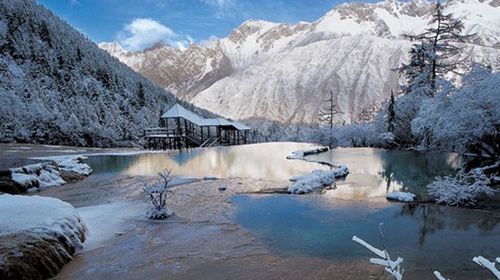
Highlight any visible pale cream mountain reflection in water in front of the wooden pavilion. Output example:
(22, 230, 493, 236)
(123, 143, 325, 181)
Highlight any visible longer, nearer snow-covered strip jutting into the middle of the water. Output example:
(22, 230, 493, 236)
(288, 165, 349, 194)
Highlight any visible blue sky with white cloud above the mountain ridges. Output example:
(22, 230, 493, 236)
(38, 0, 360, 50)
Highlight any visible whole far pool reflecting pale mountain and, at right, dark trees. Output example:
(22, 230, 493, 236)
(89, 143, 460, 200)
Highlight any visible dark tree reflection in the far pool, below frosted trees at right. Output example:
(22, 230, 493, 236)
(379, 151, 459, 195)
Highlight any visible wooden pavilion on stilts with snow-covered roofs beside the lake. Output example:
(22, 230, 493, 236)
(144, 104, 250, 149)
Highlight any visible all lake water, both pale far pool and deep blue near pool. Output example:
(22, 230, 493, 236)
(84, 143, 500, 279)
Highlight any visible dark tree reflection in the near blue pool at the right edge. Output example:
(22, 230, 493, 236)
(400, 203, 500, 245)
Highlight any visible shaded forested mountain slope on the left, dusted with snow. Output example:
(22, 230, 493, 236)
(0, 0, 208, 146)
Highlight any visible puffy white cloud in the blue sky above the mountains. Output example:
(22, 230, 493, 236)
(117, 18, 193, 51)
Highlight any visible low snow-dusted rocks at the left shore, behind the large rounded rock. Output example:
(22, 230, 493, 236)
(9, 156, 92, 190)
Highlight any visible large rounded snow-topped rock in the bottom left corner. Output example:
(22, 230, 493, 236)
(0, 194, 86, 279)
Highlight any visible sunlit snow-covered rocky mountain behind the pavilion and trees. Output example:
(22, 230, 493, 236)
(100, 0, 500, 123)
